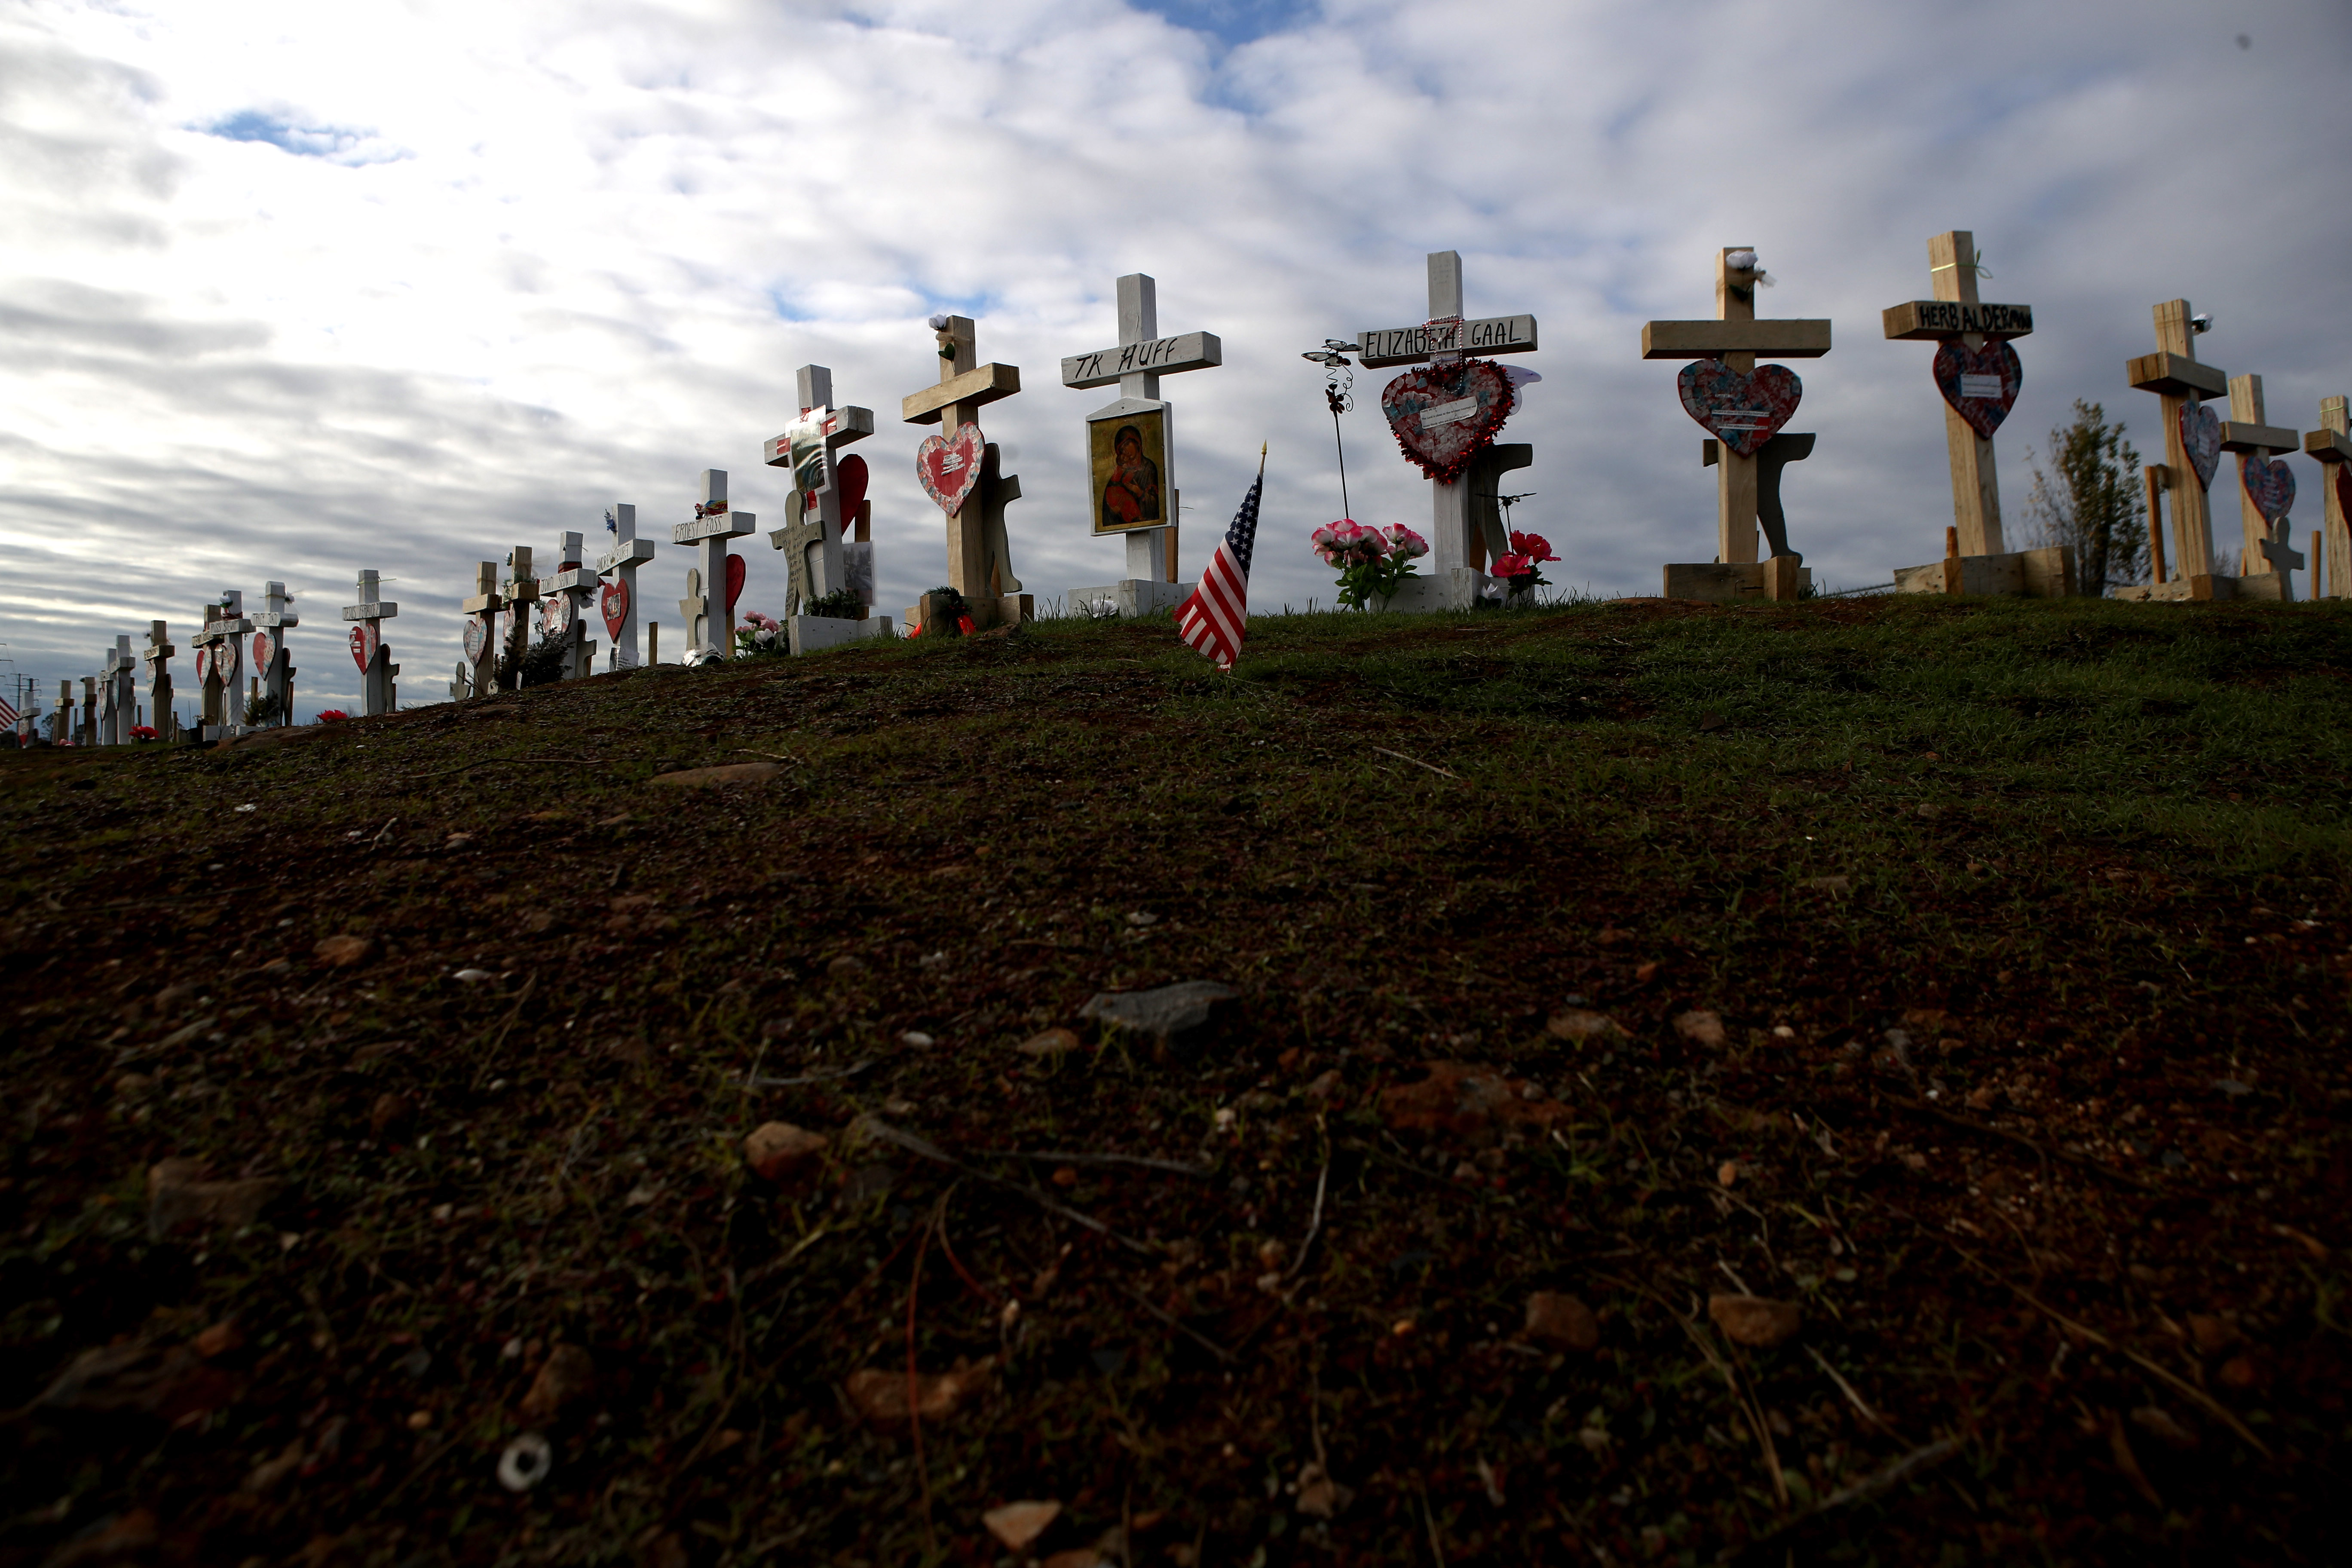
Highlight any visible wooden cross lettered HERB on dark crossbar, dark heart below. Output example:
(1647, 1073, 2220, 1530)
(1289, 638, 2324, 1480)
(1882, 228, 2034, 555)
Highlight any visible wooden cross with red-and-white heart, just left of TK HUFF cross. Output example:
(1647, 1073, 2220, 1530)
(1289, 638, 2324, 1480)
(898, 315, 1032, 630)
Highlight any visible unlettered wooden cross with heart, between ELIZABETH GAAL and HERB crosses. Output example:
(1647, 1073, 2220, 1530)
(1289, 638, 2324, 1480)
(1642, 245, 1830, 576)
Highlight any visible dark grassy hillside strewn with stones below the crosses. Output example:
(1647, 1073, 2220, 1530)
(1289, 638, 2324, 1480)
(0, 600, 2352, 1568)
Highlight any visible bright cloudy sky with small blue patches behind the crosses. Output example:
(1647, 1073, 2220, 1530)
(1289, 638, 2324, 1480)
(0, 0, 2352, 712)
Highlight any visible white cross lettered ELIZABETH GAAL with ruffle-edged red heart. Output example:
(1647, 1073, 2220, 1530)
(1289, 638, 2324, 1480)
(1355, 251, 1536, 574)
